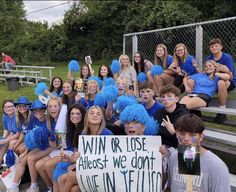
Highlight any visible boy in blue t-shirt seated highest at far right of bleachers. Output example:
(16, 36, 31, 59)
(206, 38, 236, 123)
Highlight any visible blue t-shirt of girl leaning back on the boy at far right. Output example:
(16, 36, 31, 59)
(190, 73, 220, 97)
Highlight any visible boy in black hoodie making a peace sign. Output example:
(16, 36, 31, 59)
(154, 84, 189, 148)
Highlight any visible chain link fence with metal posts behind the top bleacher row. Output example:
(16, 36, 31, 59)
(123, 17, 236, 65)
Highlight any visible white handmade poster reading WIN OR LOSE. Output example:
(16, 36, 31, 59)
(76, 136, 162, 192)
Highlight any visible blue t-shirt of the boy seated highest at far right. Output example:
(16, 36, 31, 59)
(206, 53, 236, 85)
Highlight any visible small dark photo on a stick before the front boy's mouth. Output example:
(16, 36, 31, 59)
(178, 145, 200, 175)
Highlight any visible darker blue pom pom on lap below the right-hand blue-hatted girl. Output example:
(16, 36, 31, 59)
(34, 127, 49, 151)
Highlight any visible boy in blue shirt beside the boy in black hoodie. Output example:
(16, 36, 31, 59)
(139, 81, 164, 117)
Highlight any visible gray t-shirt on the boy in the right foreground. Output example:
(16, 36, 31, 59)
(168, 150, 231, 192)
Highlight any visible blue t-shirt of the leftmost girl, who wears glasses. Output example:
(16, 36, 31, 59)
(2, 114, 20, 134)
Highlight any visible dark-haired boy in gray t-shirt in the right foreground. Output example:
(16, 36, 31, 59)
(160, 114, 231, 192)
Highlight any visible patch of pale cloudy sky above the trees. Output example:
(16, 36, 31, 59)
(23, 0, 72, 26)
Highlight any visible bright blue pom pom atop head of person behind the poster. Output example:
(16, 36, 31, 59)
(120, 104, 149, 125)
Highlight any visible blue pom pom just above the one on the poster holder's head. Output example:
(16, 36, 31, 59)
(115, 95, 137, 112)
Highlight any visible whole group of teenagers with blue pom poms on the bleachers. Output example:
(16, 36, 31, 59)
(0, 39, 236, 192)
